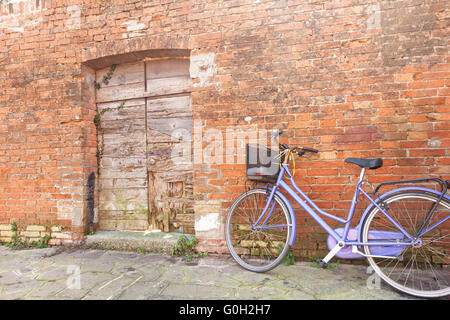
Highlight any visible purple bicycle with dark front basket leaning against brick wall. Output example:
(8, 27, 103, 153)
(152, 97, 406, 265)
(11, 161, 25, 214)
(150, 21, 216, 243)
(225, 131, 450, 298)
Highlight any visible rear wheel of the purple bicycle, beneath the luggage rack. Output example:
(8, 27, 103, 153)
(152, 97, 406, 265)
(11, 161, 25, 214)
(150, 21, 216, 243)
(361, 192, 450, 298)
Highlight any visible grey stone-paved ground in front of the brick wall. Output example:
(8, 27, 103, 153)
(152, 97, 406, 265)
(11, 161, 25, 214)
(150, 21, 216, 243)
(0, 246, 418, 300)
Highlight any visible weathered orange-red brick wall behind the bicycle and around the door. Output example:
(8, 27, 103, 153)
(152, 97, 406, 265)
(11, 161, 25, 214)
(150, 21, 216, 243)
(0, 0, 450, 256)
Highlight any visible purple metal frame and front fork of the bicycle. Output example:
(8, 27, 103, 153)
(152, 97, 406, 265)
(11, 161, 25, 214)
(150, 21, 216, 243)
(253, 164, 448, 251)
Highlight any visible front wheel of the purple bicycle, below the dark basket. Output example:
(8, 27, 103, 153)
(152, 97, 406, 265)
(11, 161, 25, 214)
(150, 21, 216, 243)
(225, 189, 292, 272)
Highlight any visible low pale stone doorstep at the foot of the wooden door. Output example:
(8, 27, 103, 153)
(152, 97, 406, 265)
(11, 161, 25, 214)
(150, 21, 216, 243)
(84, 231, 194, 254)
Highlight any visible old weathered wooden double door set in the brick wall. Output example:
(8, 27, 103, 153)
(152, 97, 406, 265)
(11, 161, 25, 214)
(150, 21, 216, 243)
(96, 58, 194, 233)
